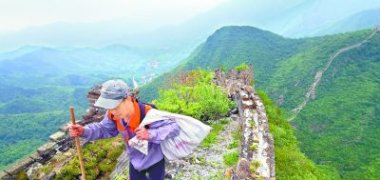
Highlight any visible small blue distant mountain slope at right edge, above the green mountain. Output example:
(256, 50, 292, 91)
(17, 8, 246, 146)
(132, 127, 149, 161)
(317, 9, 380, 35)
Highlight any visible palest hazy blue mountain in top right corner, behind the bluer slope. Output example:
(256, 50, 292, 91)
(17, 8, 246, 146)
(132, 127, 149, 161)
(272, 0, 380, 38)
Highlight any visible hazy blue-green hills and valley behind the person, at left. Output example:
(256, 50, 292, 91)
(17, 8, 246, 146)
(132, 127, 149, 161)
(0, 44, 183, 169)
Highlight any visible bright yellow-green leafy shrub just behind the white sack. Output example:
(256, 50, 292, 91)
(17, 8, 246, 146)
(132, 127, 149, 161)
(153, 70, 234, 121)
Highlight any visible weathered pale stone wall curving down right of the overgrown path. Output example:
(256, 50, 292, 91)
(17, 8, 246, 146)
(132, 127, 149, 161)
(214, 66, 275, 179)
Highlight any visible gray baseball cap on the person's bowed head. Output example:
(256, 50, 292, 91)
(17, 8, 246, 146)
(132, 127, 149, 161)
(94, 79, 130, 109)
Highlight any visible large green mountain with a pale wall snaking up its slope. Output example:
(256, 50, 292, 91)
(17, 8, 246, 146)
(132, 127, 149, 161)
(141, 26, 380, 179)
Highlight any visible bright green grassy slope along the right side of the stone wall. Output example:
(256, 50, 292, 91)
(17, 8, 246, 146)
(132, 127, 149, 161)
(258, 91, 340, 179)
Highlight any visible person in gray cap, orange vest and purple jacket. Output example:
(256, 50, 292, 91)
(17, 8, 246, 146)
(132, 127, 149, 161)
(69, 80, 180, 180)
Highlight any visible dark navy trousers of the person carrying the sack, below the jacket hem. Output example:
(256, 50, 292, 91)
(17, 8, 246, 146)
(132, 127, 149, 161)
(129, 158, 165, 180)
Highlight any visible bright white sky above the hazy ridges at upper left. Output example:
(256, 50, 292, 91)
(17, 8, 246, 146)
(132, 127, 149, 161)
(0, 0, 228, 31)
